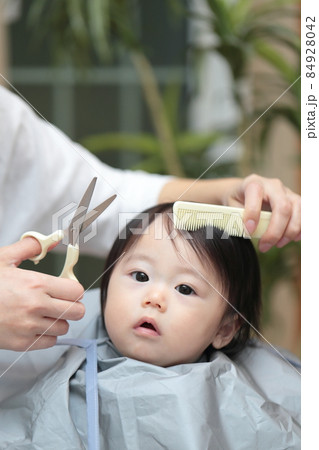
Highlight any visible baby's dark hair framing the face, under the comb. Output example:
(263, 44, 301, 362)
(101, 203, 261, 356)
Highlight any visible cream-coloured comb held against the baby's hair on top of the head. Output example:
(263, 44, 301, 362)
(173, 201, 271, 239)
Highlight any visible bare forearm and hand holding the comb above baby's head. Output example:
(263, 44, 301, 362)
(159, 174, 301, 252)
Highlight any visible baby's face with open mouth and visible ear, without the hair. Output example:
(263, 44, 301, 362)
(104, 221, 234, 367)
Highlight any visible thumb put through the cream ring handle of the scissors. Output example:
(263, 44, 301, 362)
(0, 237, 41, 267)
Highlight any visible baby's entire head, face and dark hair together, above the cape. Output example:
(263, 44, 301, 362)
(101, 204, 261, 367)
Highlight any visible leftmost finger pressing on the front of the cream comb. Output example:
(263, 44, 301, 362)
(243, 181, 264, 234)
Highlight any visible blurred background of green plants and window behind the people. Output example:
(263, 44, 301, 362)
(0, 0, 300, 355)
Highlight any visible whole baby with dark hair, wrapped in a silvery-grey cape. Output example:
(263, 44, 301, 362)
(0, 204, 300, 450)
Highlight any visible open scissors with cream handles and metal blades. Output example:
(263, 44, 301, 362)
(20, 177, 116, 281)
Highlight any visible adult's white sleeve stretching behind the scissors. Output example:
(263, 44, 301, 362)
(0, 87, 169, 257)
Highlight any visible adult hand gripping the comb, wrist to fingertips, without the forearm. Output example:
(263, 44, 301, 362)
(225, 174, 301, 252)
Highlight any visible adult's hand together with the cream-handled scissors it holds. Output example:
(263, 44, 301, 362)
(0, 179, 115, 351)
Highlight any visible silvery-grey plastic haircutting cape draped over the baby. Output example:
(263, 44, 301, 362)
(0, 318, 300, 450)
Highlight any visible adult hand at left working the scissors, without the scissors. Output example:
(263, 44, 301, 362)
(0, 237, 85, 351)
